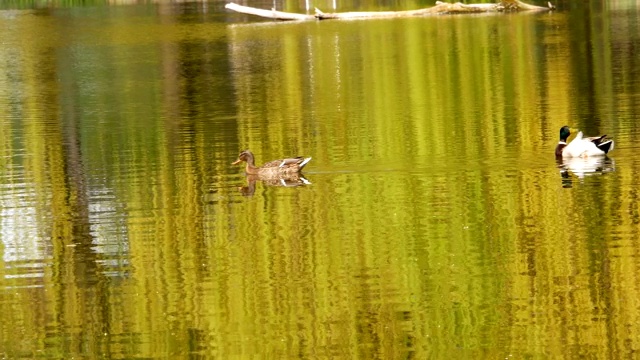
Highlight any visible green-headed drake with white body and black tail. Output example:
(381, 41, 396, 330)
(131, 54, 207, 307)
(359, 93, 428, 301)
(556, 126, 613, 158)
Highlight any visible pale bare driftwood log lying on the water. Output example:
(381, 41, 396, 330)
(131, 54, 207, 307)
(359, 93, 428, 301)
(225, 0, 554, 20)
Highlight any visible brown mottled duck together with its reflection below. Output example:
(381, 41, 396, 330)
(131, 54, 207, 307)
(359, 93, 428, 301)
(233, 150, 311, 196)
